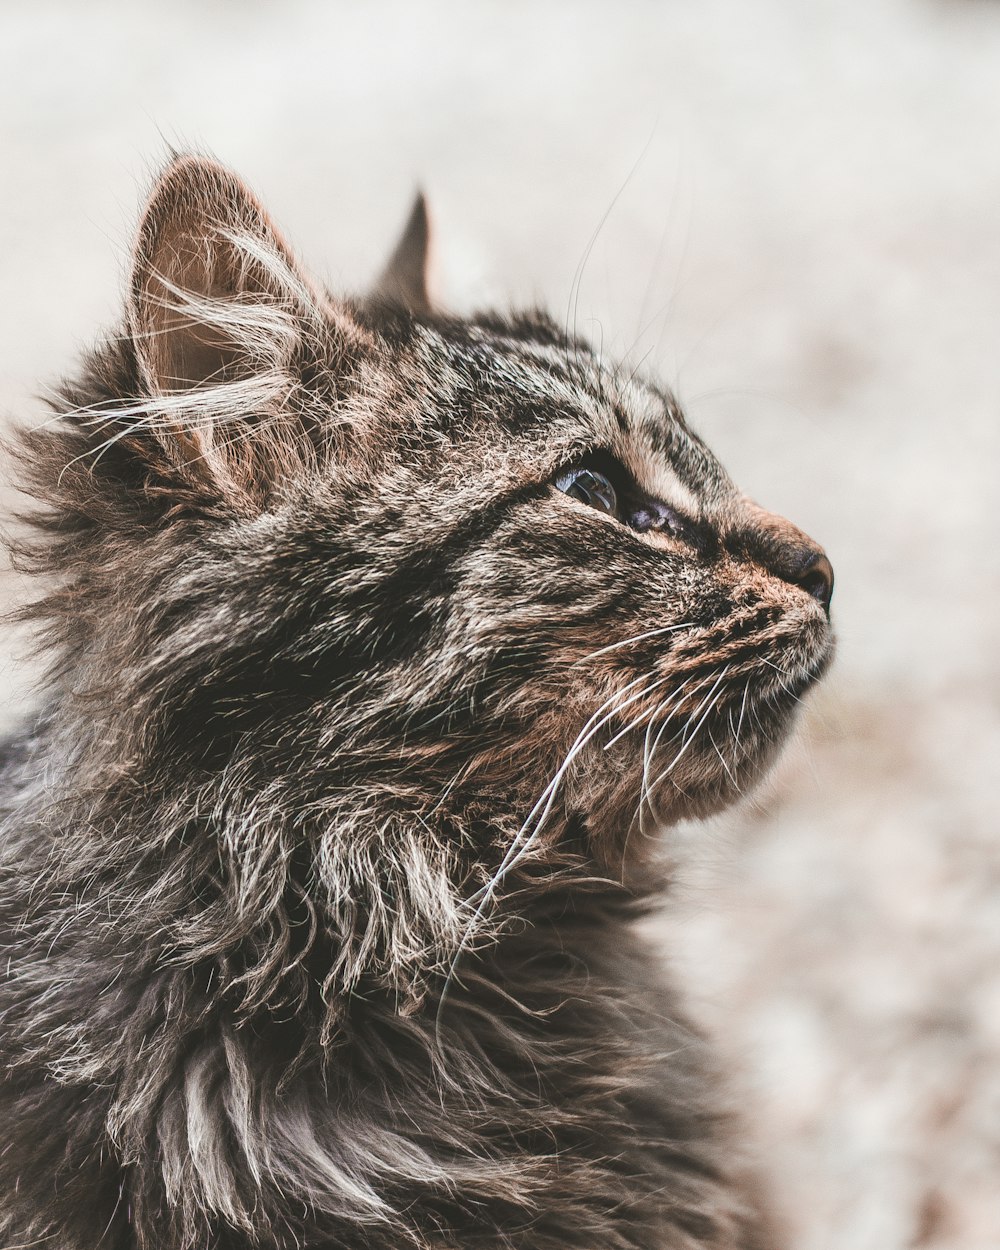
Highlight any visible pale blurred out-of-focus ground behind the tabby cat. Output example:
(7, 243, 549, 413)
(0, 0, 1000, 1250)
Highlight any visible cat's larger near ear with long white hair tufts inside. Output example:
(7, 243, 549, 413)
(123, 156, 339, 503)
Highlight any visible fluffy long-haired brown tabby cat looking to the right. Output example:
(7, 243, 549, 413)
(0, 155, 833, 1250)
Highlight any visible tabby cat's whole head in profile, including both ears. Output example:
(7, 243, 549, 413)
(29, 158, 833, 873)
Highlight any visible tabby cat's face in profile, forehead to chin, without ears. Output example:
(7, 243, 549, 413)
(308, 314, 833, 861)
